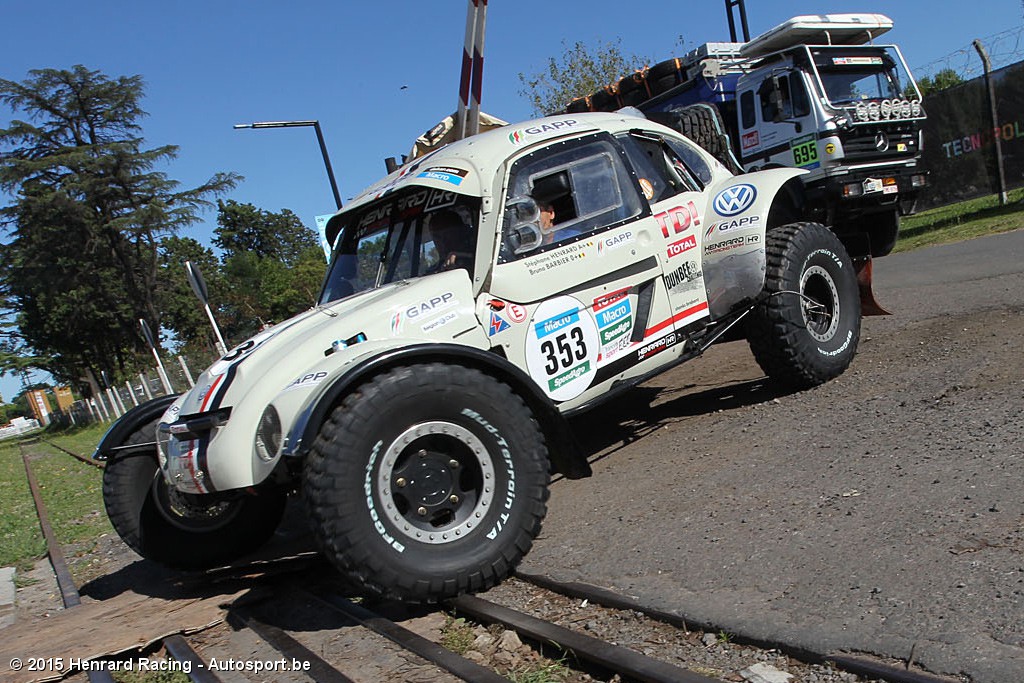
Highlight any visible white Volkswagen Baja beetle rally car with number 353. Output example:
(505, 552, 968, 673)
(97, 114, 860, 601)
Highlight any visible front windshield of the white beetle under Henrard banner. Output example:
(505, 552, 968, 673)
(319, 187, 480, 304)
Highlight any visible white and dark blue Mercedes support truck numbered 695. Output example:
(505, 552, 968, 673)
(566, 14, 928, 313)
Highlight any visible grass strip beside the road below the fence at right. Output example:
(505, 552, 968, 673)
(893, 187, 1024, 252)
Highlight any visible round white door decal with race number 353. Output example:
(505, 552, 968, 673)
(526, 296, 601, 401)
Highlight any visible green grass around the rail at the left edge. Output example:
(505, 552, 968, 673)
(0, 428, 113, 572)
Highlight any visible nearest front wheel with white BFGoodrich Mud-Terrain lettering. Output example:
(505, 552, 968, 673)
(305, 364, 550, 602)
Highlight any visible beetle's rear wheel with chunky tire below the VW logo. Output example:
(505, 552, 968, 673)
(746, 223, 860, 389)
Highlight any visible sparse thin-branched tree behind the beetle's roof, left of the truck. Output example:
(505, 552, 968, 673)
(519, 41, 650, 116)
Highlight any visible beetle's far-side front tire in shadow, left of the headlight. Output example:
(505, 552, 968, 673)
(103, 420, 287, 569)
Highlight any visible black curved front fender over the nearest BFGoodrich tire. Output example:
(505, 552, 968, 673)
(282, 343, 591, 479)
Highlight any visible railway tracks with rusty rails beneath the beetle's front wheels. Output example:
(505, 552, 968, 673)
(8, 444, 952, 683)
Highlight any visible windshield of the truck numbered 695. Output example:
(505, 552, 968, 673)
(812, 46, 921, 105)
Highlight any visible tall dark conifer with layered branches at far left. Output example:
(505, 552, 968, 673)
(0, 65, 239, 389)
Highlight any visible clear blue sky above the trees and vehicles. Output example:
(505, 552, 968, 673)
(0, 0, 1024, 398)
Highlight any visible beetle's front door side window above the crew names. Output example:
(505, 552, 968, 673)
(501, 136, 644, 260)
